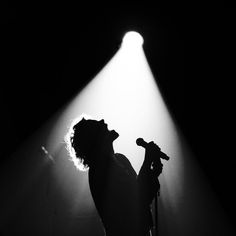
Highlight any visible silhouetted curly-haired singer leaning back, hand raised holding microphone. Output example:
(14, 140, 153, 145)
(65, 118, 162, 236)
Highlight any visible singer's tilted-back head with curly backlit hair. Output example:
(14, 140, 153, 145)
(65, 115, 119, 169)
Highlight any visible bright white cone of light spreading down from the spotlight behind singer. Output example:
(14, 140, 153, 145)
(7, 33, 229, 236)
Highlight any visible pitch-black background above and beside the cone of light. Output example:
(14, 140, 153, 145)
(0, 4, 236, 230)
